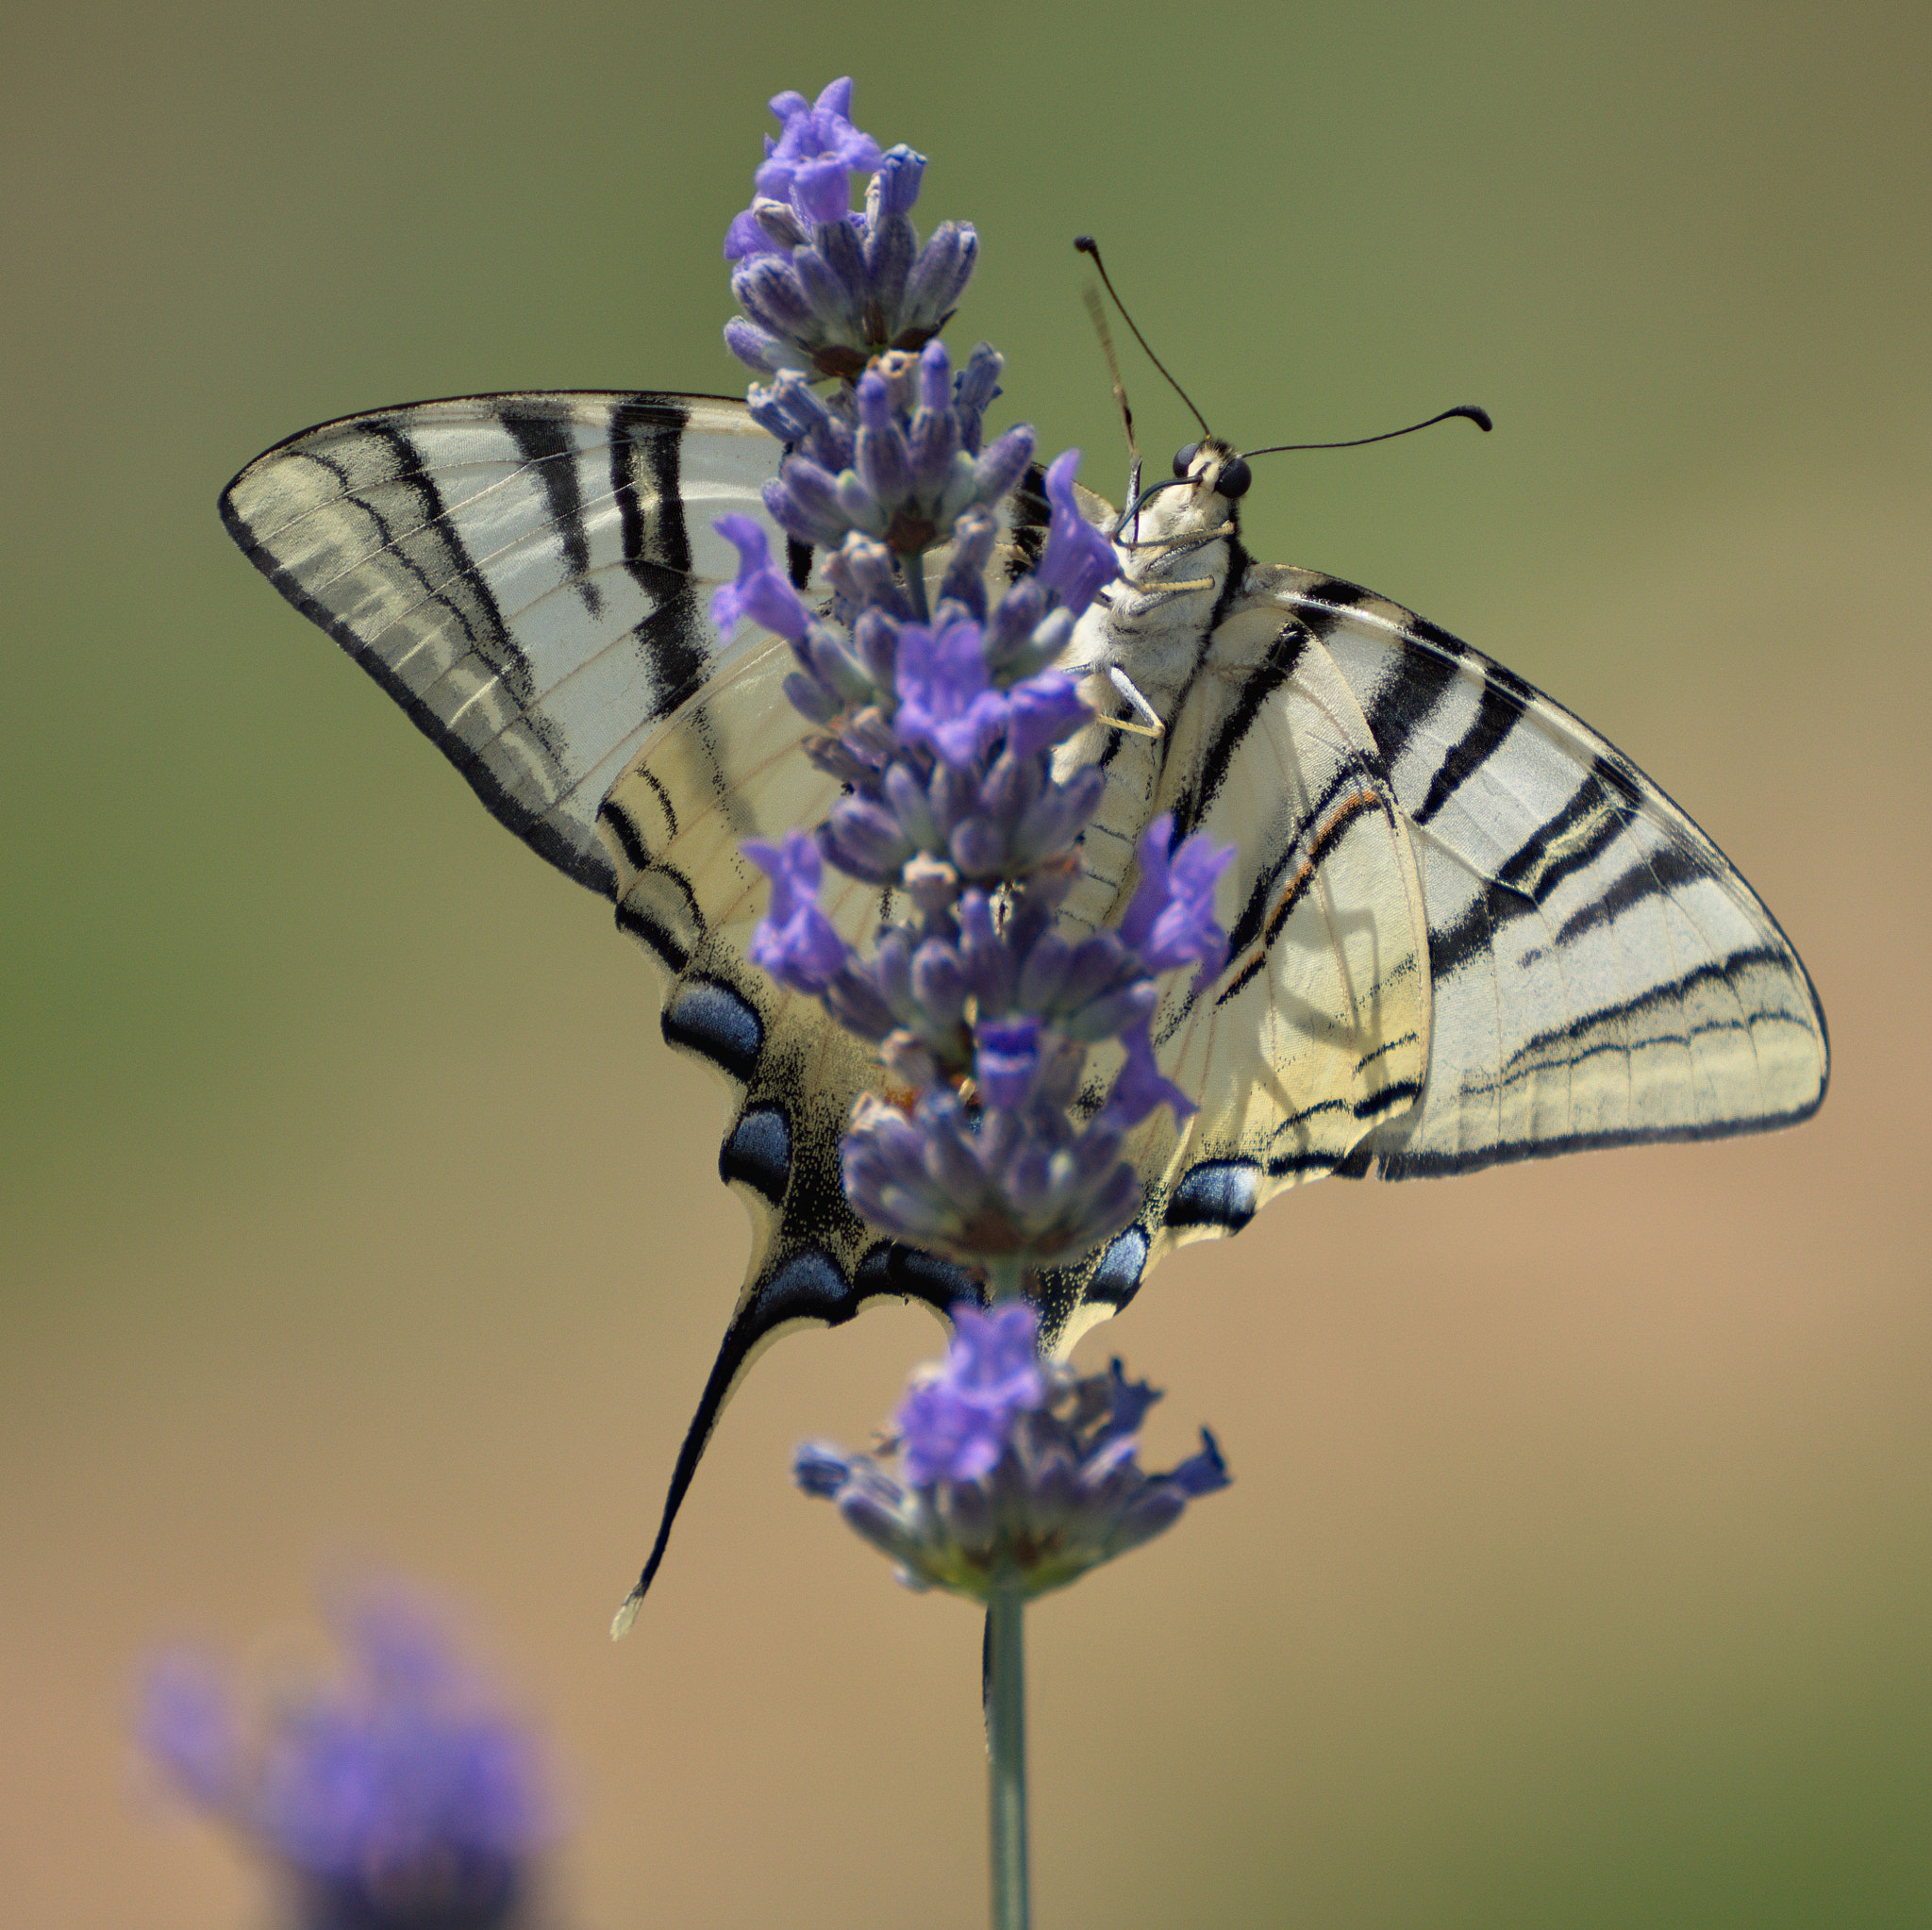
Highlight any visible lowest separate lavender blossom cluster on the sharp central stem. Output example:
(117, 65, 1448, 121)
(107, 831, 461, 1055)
(792, 1302, 1229, 1602)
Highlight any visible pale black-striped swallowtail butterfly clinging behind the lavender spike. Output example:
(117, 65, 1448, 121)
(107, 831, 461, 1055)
(220, 380, 1827, 1622)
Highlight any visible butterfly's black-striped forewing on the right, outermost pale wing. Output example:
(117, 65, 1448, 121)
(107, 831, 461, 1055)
(1244, 568, 1827, 1178)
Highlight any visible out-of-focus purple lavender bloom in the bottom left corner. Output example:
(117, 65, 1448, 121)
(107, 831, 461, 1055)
(142, 1594, 553, 1930)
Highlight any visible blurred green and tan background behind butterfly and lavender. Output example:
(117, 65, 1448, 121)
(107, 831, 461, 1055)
(0, 0, 1932, 1930)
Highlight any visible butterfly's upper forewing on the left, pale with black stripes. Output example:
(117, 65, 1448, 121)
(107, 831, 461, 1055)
(223, 394, 809, 892)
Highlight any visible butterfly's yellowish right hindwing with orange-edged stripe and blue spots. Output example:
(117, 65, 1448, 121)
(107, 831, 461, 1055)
(1060, 607, 1430, 1333)
